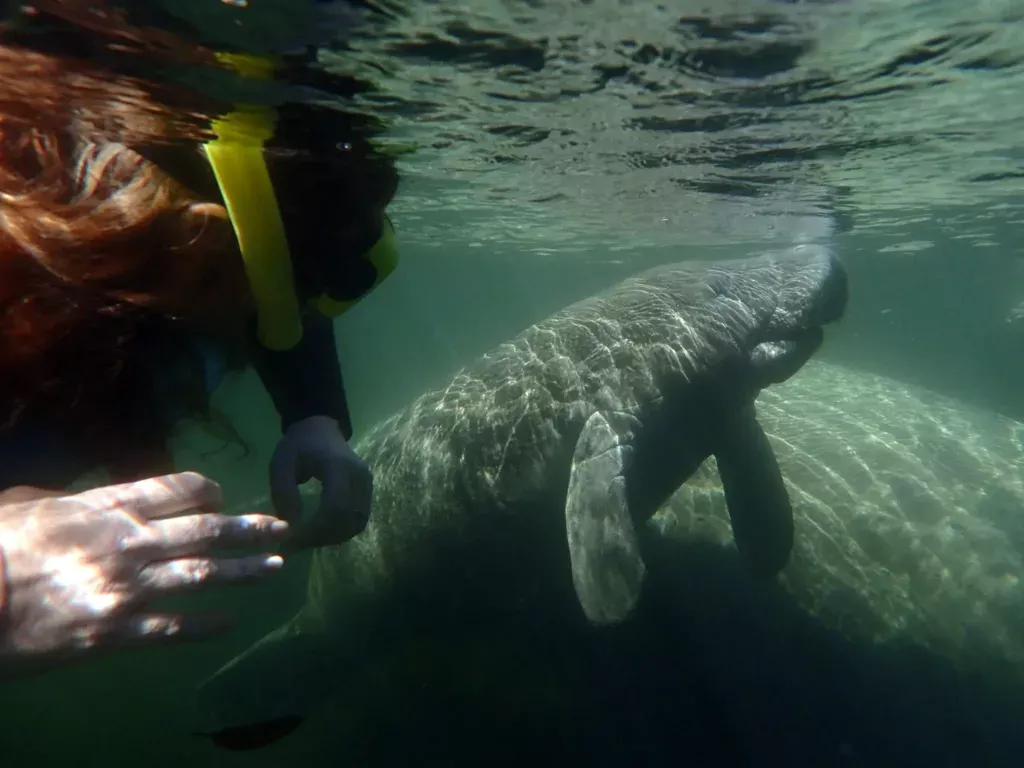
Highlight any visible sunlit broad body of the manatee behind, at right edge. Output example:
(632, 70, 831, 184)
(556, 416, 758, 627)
(650, 361, 1024, 680)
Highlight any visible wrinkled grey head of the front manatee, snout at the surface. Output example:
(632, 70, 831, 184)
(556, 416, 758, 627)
(618, 245, 848, 409)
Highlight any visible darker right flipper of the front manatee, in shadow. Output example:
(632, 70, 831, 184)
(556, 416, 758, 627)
(715, 404, 794, 577)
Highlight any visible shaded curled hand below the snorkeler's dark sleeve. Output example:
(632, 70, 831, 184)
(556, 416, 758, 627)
(270, 416, 374, 552)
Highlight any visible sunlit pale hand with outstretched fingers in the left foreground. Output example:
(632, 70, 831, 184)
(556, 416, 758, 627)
(0, 472, 288, 676)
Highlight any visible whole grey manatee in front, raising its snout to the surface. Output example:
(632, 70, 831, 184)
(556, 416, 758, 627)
(200, 244, 847, 748)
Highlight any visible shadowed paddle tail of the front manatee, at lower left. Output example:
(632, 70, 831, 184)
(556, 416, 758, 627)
(199, 612, 333, 750)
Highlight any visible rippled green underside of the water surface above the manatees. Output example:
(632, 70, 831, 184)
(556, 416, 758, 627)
(280, 0, 1024, 253)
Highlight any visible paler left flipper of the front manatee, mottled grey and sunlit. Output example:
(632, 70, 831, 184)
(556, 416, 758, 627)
(565, 412, 645, 625)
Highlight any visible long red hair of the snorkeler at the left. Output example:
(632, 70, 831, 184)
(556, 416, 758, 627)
(0, 31, 249, 487)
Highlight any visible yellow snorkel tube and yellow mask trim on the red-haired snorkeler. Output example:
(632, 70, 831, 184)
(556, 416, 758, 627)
(198, 53, 398, 350)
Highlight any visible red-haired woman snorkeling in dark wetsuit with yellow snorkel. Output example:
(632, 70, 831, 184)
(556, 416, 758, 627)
(0, 2, 397, 671)
